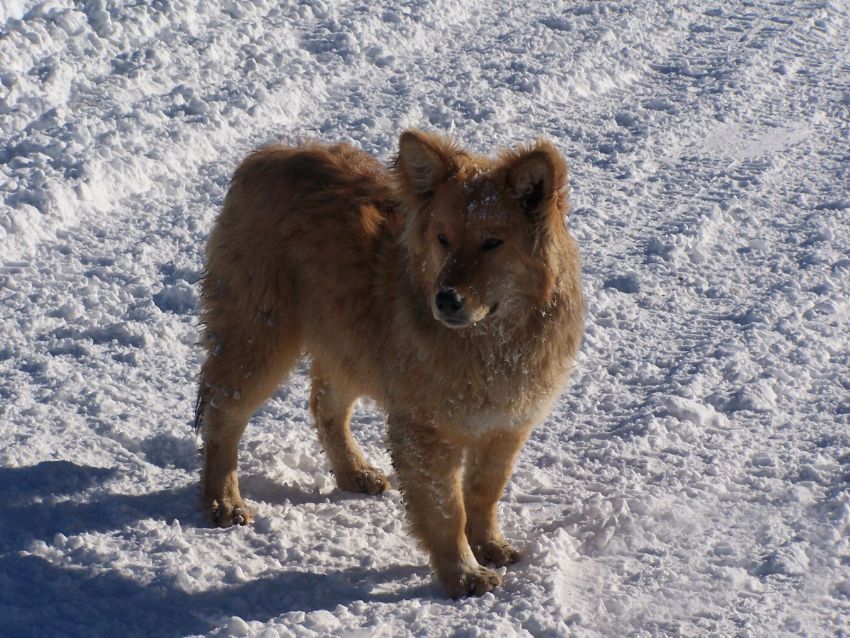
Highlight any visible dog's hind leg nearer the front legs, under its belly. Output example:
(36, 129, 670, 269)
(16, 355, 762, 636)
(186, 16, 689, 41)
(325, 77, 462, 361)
(310, 362, 390, 494)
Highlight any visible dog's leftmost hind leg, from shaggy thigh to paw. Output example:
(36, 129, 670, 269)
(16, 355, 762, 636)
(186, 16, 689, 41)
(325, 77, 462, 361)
(198, 322, 300, 527)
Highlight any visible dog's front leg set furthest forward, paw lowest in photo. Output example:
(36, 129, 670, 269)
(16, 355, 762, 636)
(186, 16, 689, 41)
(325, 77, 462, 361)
(389, 416, 502, 598)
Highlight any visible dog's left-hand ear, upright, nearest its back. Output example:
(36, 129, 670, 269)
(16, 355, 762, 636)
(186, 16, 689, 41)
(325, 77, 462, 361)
(396, 130, 457, 198)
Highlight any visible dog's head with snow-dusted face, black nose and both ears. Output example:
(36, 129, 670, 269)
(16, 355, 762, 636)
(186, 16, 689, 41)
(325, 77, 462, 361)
(395, 131, 569, 328)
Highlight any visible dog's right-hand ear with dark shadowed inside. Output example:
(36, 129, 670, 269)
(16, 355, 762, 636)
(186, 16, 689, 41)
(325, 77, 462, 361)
(505, 140, 567, 221)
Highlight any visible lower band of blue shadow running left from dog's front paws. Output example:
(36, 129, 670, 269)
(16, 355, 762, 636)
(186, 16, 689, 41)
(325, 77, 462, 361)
(0, 553, 430, 638)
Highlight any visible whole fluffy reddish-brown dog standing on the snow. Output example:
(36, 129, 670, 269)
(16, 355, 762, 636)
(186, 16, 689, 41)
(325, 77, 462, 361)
(196, 131, 584, 596)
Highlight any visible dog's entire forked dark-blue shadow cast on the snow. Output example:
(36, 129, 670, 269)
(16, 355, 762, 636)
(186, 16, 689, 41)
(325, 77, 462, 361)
(0, 461, 440, 638)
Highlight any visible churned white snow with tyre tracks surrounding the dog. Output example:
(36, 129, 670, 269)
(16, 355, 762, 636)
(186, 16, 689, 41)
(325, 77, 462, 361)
(0, 0, 850, 637)
